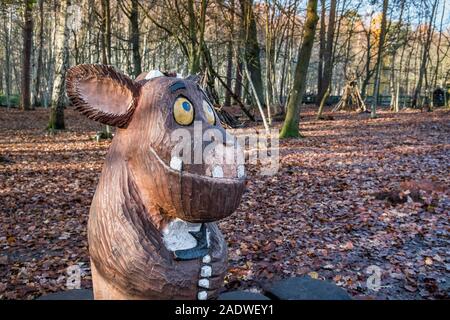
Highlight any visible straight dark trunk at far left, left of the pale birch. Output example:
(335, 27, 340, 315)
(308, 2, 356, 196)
(20, 0, 34, 110)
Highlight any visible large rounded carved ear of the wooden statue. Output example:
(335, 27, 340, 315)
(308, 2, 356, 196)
(66, 64, 140, 128)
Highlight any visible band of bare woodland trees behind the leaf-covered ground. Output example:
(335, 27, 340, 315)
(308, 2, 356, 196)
(0, 0, 450, 128)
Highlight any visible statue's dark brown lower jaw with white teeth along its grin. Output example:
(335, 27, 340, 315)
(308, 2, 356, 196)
(143, 148, 245, 223)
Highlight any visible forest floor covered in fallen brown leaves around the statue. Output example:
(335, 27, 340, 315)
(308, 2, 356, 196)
(0, 108, 450, 299)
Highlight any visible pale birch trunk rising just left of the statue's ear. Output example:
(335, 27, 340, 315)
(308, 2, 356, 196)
(48, 0, 70, 130)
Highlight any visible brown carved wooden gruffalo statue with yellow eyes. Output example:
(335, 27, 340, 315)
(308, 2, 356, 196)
(66, 65, 245, 300)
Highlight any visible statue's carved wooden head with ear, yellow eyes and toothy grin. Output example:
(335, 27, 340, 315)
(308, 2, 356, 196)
(66, 65, 245, 225)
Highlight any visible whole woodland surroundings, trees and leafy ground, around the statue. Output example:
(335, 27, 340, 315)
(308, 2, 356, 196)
(0, 0, 450, 299)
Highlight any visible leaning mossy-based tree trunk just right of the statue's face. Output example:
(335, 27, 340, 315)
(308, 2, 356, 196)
(280, 0, 319, 138)
